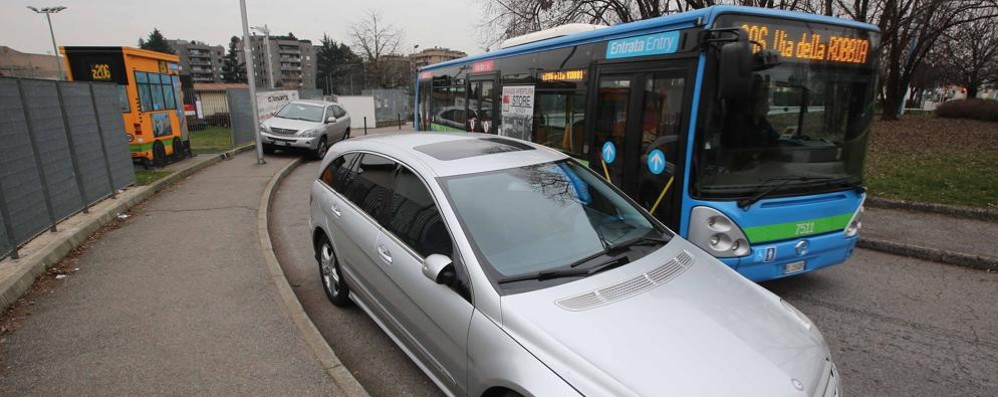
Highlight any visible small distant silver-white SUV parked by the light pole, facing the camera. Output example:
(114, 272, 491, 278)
(260, 100, 350, 159)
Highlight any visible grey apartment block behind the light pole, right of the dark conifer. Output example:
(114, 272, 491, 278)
(239, 35, 317, 88)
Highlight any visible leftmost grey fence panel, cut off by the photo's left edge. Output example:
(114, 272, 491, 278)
(0, 79, 53, 246)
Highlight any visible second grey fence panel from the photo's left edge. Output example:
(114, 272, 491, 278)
(21, 80, 83, 219)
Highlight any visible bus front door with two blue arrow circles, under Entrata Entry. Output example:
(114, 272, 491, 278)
(589, 64, 691, 230)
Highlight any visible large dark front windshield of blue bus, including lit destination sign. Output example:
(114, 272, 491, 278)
(694, 16, 877, 198)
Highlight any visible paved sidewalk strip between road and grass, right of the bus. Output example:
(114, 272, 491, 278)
(860, 206, 998, 267)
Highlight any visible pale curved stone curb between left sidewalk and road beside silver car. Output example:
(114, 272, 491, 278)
(256, 158, 369, 397)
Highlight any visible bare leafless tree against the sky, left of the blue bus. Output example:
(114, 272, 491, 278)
(350, 9, 403, 87)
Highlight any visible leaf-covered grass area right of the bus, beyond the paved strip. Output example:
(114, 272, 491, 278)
(866, 117, 998, 208)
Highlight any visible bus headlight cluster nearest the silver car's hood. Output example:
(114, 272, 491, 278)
(689, 207, 751, 258)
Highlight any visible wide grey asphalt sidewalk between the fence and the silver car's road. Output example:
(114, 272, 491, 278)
(0, 152, 341, 395)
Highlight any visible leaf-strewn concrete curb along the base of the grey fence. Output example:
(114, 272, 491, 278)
(0, 146, 253, 311)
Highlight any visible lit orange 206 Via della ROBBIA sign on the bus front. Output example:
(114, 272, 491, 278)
(734, 22, 870, 65)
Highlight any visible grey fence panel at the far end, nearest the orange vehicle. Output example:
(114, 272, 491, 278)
(94, 84, 135, 189)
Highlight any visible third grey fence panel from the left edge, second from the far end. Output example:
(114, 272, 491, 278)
(61, 83, 111, 203)
